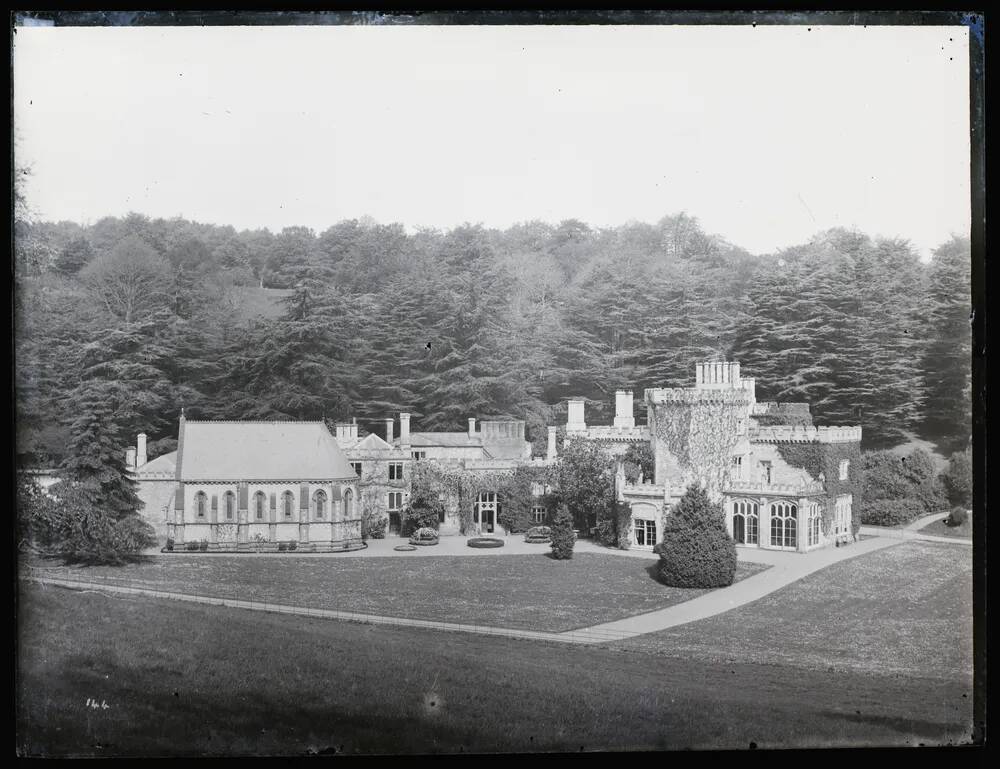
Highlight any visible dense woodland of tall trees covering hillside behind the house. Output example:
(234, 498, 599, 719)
(14, 207, 971, 465)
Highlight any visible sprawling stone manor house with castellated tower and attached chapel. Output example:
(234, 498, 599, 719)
(127, 362, 861, 552)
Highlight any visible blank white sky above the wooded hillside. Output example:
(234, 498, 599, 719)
(14, 26, 970, 255)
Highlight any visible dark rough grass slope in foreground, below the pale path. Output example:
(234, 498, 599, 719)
(15, 584, 972, 756)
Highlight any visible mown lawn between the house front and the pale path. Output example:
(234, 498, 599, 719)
(21, 553, 766, 632)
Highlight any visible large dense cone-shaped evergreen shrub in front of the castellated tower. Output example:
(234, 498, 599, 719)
(653, 484, 736, 588)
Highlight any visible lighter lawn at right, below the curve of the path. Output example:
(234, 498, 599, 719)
(615, 541, 972, 681)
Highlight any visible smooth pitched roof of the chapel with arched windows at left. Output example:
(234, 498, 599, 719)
(177, 421, 357, 481)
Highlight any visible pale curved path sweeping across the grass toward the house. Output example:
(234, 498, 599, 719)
(26, 537, 916, 644)
